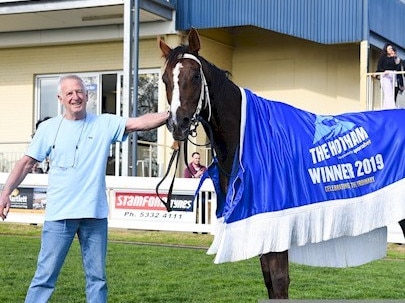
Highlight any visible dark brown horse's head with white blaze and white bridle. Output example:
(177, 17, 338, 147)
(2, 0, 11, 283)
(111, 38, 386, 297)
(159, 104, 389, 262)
(159, 29, 210, 141)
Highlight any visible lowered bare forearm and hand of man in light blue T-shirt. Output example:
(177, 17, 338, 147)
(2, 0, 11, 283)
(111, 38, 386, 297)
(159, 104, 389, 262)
(0, 156, 37, 221)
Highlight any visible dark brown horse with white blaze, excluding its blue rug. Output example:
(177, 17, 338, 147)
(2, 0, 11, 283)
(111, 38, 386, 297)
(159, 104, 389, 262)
(158, 28, 405, 299)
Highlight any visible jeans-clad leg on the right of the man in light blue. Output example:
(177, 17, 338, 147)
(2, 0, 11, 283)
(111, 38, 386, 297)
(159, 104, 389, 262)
(78, 219, 108, 303)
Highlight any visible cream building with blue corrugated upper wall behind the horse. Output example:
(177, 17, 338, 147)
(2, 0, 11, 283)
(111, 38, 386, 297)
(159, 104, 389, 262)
(0, 0, 405, 176)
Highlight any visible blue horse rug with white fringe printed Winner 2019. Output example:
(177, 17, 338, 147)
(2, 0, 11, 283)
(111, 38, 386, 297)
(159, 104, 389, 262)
(201, 89, 405, 267)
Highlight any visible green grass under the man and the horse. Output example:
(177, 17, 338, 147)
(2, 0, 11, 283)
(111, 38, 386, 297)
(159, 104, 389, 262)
(0, 223, 405, 303)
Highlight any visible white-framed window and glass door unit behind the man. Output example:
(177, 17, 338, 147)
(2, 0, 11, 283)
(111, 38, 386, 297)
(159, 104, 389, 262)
(34, 69, 159, 176)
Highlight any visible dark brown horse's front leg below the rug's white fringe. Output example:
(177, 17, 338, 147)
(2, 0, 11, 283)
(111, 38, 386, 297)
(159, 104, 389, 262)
(260, 251, 290, 299)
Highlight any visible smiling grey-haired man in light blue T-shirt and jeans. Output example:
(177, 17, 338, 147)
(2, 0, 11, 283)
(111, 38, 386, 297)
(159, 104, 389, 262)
(0, 75, 168, 303)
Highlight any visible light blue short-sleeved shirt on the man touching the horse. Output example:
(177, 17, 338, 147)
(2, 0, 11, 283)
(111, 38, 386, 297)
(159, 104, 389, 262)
(26, 113, 127, 221)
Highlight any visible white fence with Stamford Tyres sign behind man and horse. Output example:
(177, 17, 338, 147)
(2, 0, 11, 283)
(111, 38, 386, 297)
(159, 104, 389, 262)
(0, 173, 216, 234)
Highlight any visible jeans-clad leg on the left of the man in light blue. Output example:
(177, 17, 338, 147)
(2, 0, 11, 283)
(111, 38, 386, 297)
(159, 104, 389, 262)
(25, 220, 78, 303)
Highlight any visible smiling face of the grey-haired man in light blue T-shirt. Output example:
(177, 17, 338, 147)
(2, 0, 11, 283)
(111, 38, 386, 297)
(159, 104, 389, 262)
(58, 79, 87, 115)
